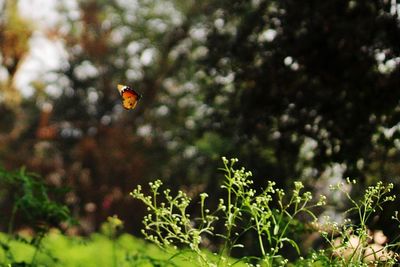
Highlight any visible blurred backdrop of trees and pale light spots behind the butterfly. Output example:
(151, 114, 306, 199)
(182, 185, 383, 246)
(0, 0, 400, 244)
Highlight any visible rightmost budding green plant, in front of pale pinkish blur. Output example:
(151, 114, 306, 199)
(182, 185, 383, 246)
(319, 179, 399, 266)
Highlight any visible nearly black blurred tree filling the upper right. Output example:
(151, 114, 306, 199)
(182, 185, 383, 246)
(198, 0, 400, 188)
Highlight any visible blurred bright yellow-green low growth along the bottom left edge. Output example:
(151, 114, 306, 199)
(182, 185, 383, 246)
(0, 231, 250, 267)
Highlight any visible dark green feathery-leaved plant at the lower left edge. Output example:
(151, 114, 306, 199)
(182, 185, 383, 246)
(0, 168, 73, 266)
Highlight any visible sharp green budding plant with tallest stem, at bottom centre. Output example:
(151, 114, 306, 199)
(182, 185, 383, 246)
(131, 158, 325, 266)
